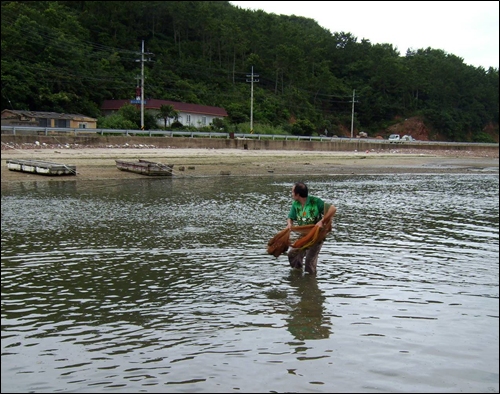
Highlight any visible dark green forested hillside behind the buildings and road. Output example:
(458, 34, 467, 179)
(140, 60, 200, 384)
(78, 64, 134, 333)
(1, 1, 499, 142)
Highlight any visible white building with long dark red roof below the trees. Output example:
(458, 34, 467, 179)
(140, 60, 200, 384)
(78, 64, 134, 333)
(101, 99, 228, 127)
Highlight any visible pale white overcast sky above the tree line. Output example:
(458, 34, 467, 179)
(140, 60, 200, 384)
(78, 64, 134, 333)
(230, 1, 499, 70)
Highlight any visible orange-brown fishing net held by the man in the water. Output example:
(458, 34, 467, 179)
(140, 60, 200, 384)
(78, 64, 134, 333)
(267, 203, 336, 258)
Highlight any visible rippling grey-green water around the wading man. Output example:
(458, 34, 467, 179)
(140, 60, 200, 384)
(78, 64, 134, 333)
(1, 174, 499, 393)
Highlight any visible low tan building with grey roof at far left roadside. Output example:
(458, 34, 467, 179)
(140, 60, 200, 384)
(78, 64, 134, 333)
(2, 109, 97, 129)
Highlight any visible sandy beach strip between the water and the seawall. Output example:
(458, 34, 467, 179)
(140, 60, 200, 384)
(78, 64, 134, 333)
(1, 145, 498, 183)
